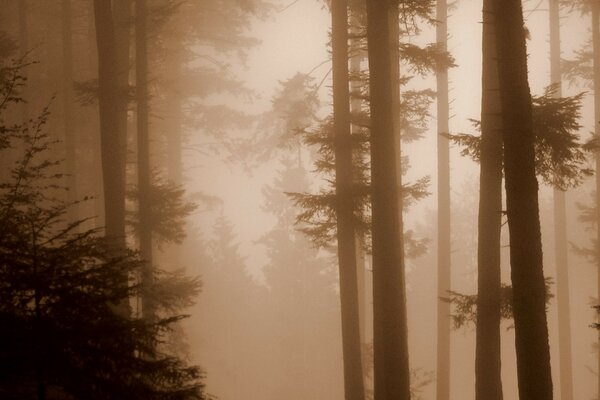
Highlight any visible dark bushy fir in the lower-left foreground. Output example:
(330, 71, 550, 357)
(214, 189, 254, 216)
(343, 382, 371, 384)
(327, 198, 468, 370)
(0, 67, 204, 400)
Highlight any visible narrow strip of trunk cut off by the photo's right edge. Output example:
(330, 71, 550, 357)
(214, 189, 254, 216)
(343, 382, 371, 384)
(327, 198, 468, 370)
(592, 1, 600, 396)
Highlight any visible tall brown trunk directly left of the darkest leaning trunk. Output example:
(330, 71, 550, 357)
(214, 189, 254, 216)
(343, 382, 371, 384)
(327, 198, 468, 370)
(475, 0, 502, 400)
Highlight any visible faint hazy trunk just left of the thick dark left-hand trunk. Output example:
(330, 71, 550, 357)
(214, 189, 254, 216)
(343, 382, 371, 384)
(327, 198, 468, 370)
(62, 0, 79, 221)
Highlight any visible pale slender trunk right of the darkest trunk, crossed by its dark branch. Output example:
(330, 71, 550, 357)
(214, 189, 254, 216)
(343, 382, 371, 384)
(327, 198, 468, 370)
(549, 0, 573, 400)
